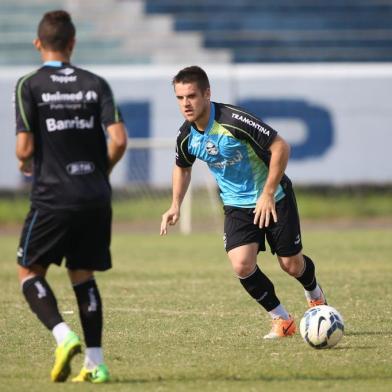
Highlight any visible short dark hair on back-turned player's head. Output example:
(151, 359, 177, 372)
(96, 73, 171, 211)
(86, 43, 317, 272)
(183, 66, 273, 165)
(37, 10, 76, 52)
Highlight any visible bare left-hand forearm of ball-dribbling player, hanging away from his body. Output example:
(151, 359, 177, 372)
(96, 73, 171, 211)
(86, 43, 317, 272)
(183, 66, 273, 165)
(160, 165, 192, 235)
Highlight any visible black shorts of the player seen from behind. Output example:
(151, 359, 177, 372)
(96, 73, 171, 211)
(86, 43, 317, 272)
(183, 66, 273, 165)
(17, 206, 112, 271)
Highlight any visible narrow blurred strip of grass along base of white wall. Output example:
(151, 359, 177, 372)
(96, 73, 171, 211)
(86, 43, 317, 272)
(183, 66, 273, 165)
(0, 188, 392, 228)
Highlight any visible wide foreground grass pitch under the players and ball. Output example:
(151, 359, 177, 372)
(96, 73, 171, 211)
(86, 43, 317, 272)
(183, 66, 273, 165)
(0, 229, 392, 392)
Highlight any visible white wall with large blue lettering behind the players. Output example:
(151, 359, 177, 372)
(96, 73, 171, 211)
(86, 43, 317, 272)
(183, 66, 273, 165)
(0, 64, 392, 188)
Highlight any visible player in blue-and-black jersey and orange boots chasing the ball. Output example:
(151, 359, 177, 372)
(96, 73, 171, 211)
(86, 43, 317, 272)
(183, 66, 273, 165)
(160, 66, 326, 339)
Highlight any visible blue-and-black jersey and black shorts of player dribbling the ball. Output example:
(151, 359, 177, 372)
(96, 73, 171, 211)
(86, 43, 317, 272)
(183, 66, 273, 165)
(176, 102, 302, 256)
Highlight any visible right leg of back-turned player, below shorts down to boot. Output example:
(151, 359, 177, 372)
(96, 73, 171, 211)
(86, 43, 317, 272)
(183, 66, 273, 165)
(68, 270, 109, 383)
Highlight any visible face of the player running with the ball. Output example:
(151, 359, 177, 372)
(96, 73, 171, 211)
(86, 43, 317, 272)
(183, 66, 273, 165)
(174, 82, 211, 123)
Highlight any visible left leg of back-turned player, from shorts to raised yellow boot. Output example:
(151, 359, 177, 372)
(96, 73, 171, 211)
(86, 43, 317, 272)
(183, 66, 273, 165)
(18, 210, 81, 381)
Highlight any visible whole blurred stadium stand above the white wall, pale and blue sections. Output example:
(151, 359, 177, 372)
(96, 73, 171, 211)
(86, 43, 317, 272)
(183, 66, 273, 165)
(0, 0, 392, 65)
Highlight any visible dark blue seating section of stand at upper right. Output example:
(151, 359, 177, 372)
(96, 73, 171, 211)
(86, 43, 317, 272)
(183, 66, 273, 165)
(146, 0, 392, 63)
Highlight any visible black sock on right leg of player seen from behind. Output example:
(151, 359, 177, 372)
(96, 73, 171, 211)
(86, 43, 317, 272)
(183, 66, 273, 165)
(74, 279, 102, 347)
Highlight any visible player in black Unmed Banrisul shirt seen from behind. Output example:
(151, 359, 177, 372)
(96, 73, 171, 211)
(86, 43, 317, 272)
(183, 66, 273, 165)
(15, 11, 127, 383)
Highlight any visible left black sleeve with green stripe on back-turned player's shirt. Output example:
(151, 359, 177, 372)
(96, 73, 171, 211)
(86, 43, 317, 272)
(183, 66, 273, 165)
(14, 75, 35, 133)
